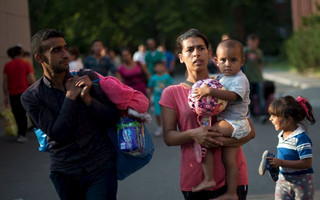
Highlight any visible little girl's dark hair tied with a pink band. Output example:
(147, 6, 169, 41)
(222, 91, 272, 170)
(268, 96, 316, 124)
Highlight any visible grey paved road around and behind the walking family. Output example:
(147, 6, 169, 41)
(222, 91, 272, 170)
(0, 70, 320, 200)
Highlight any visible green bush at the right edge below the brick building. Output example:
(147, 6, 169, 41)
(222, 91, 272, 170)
(285, 16, 320, 72)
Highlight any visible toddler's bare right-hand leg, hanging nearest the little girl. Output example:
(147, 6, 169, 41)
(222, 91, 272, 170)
(215, 147, 239, 200)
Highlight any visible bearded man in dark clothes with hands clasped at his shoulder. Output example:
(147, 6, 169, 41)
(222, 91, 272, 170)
(21, 29, 119, 200)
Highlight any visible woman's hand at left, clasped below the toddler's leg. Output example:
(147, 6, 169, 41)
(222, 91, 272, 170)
(192, 126, 223, 148)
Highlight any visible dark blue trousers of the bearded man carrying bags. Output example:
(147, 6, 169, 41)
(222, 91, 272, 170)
(50, 162, 118, 200)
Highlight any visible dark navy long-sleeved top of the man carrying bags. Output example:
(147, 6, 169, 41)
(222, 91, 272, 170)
(21, 70, 119, 175)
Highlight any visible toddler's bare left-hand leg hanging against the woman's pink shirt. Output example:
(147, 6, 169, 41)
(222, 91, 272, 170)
(192, 149, 216, 192)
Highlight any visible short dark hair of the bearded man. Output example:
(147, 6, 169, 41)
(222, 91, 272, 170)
(31, 29, 64, 55)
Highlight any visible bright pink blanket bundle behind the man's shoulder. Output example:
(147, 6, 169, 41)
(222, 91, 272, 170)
(98, 74, 149, 113)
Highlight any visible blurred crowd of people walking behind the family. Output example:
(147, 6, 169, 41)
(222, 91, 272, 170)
(3, 31, 269, 142)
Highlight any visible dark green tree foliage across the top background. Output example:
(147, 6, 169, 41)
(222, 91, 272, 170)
(29, 0, 287, 53)
